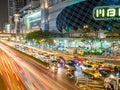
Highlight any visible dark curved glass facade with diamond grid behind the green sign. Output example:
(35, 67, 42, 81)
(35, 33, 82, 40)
(56, 0, 120, 31)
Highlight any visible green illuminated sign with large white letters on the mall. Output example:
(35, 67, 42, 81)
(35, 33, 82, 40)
(93, 6, 120, 20)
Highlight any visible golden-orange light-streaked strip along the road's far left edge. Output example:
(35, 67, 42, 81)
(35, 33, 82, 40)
(0, 46, 26, 90)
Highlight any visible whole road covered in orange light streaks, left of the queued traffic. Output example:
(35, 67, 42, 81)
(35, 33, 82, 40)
(0, 44, 79, 90)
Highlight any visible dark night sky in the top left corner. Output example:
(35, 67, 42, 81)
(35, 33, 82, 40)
(0, 0, 8, 29)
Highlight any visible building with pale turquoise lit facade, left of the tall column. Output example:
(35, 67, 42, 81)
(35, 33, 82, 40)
(19, 0, 41, 33)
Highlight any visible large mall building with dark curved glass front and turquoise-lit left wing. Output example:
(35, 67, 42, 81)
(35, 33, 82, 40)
(20, 0, 120, 32)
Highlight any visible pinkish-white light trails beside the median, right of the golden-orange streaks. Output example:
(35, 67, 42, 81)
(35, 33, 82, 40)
(0, 44, 78, 90)
